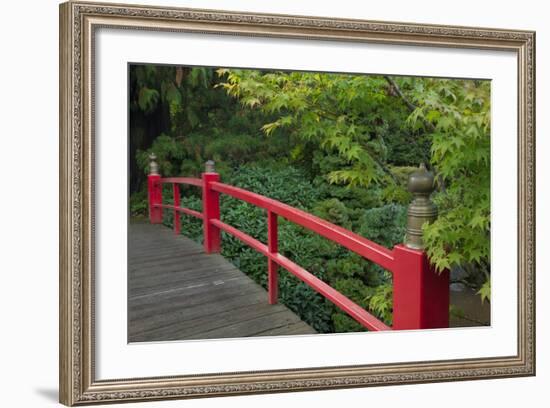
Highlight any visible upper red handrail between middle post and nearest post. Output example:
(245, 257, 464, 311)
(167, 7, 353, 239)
(212, 182, 394, 270)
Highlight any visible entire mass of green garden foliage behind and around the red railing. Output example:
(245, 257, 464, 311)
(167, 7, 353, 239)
(130, 65, 490, 332)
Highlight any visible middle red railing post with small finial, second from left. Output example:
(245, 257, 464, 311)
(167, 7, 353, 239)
(202, 160, 221, 254)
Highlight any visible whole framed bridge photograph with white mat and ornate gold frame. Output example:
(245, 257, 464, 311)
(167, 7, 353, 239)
(60, 2, 535, 405)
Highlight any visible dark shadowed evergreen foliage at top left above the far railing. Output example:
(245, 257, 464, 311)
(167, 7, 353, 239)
(130, 65, 280, 192)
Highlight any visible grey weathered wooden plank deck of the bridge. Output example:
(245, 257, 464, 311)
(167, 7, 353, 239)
(128, 223, 315, 342)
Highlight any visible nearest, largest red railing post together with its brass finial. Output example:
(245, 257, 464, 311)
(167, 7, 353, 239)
(393, 165, 449, 330)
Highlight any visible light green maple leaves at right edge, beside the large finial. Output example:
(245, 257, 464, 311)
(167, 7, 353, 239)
(402, 79, 490, 286)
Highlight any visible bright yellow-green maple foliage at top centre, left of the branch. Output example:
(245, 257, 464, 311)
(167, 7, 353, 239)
(218, 69, 412, 186)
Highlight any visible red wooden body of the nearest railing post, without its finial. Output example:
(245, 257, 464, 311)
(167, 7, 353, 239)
(393, 245, 449, 330)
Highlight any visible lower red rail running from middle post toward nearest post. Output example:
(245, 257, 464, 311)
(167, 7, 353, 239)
(212, 220, 391, 331)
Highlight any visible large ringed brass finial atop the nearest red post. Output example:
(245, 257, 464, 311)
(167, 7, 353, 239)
(405, 163, 437, 249)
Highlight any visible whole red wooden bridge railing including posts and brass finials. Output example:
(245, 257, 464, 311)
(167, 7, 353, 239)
(148, 156, 449, 331)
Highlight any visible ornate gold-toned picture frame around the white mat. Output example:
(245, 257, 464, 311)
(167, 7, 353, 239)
(59, 2, 535, 405)
